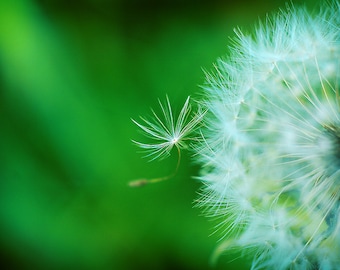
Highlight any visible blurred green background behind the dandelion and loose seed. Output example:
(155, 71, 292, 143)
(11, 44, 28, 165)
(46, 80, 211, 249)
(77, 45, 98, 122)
(0, 0, 313, 269)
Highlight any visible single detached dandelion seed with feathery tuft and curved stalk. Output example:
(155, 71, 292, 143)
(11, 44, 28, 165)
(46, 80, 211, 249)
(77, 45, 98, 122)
(130, 96, 205, 187)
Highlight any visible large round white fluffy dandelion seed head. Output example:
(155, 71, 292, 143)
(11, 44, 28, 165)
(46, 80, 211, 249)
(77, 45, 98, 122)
(195, 2, 340, 269)
